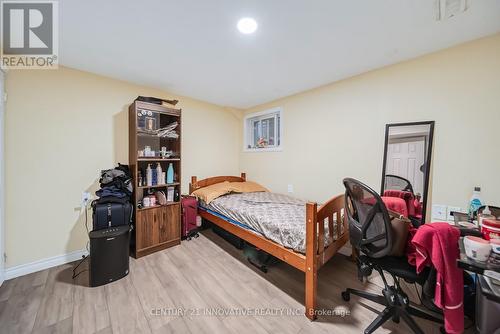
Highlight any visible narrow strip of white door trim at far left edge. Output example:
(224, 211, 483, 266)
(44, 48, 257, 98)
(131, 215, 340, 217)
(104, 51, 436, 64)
(0, 70, 5, 285)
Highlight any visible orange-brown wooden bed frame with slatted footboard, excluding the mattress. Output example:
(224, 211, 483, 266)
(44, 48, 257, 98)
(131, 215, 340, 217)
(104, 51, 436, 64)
(189, 173, 349, 320)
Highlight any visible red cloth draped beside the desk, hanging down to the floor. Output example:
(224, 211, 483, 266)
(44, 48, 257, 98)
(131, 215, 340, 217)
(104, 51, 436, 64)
(408, 223, 464, 333)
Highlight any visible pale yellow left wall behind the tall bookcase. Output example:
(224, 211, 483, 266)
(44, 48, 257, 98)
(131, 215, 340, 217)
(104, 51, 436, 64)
(5, 68, 240, 267)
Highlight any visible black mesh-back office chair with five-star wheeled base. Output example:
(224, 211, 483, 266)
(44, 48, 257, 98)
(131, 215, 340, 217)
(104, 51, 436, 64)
(342, 178, 443, 334)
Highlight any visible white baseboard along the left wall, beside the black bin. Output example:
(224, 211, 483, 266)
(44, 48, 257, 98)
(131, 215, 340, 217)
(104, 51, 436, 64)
(4, 249, 88, 280)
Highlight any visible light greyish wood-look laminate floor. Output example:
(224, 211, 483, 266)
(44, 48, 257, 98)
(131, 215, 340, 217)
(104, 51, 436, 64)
(0, 231, 458, 334)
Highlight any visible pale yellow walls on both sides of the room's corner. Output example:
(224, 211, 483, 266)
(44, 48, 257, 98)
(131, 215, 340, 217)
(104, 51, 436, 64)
(5, 35, 500, 267)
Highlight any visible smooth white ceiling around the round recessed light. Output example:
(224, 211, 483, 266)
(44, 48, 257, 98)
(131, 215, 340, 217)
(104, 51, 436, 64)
(60, 0, 500, 108)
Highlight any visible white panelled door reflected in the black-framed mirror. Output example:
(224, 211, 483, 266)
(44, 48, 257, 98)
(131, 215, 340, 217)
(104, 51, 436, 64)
(386, 138, 425, 194)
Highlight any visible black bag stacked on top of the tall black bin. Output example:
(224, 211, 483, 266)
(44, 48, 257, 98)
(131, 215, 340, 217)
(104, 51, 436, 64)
(92, 202, 132, 231)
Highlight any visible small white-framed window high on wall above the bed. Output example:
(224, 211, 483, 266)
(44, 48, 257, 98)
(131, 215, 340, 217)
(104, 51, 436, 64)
(243, 108, 283, 151)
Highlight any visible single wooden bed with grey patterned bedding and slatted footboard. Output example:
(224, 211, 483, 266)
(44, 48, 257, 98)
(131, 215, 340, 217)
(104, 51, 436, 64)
(189, 173, 349, 320)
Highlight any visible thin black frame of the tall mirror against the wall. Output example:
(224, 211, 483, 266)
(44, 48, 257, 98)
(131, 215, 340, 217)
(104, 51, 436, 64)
(380, 121, 436, 225)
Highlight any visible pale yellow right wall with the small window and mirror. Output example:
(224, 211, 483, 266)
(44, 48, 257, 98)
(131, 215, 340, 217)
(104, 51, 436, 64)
(240, 34, 500, 211)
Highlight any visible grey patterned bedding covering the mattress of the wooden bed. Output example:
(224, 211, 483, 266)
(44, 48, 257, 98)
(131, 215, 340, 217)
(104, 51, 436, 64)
(203, 192, 332, 253)
